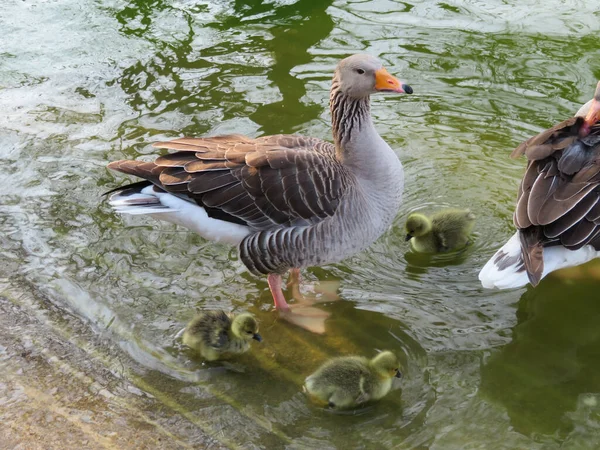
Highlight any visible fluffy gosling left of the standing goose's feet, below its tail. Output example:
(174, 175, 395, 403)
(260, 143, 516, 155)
(182, 311, 262, 361)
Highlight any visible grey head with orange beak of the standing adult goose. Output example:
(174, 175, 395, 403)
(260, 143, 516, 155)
(334, 54, 413, 98)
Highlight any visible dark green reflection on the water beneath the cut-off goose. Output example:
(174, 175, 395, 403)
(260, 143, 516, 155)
(481, 270, 600, 439)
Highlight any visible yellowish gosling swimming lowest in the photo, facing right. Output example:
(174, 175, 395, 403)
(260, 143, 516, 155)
(304, 351, 402, 409)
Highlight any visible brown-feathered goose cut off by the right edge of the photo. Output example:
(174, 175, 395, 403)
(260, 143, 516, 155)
(479, 82, 600, 289)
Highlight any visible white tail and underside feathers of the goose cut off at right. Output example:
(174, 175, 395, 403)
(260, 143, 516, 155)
(479, 231, 600, 289)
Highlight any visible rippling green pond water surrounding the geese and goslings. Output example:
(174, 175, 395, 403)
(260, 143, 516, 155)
(0, 0, 600, 449)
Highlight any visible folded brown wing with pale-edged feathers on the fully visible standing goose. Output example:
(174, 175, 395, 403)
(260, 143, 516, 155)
(108, 135, 351, 230)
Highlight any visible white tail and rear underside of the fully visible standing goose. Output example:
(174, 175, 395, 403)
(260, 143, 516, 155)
(109, 186, 250, 245)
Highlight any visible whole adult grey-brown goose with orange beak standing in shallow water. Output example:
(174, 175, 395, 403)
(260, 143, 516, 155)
(108, 55, 412, 332)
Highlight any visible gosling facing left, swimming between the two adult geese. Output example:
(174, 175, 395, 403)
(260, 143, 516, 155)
(406, 209, 475, 253)
